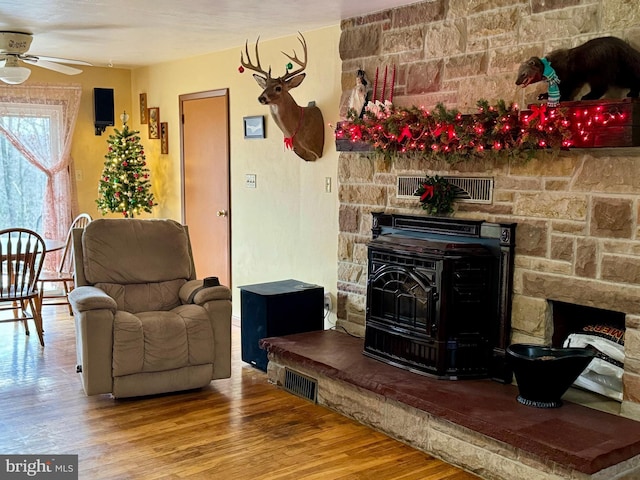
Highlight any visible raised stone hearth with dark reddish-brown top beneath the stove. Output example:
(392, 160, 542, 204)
(261, 330, 640, 480)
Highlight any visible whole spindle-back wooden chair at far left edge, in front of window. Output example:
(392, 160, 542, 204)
(0, 228, 46, 347)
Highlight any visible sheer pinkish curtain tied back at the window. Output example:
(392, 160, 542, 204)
(0, 84, 82, 244)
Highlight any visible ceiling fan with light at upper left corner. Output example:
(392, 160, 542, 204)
(0, 32, 91, 85)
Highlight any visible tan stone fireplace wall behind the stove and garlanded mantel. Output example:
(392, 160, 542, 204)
(338, 0, 640, 418)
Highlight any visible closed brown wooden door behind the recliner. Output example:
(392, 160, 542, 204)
(179, 89, 231, 287)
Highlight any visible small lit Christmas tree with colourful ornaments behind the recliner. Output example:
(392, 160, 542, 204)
(96, 113, 157, 218)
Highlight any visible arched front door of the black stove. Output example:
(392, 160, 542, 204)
(367, 265, 438, 338)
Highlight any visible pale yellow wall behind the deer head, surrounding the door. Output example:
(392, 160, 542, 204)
(130, 26, 341, 319)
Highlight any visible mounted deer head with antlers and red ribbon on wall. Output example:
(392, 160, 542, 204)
(240, 33, 324, 161)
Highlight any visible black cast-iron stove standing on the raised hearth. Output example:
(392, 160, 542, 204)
(364, 213, 515, 382)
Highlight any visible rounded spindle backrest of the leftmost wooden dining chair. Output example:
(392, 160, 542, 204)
(0, 228, 46, 300)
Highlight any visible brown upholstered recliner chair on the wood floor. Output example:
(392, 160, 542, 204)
(69, 219, 231, 398)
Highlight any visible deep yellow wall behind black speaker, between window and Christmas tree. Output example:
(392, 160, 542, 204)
(25, 67, 133, 218)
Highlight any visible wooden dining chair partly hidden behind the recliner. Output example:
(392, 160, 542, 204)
(38, 213, 92, 315)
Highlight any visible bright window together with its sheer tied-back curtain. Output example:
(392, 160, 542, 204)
(0, 84, 82, 244)
